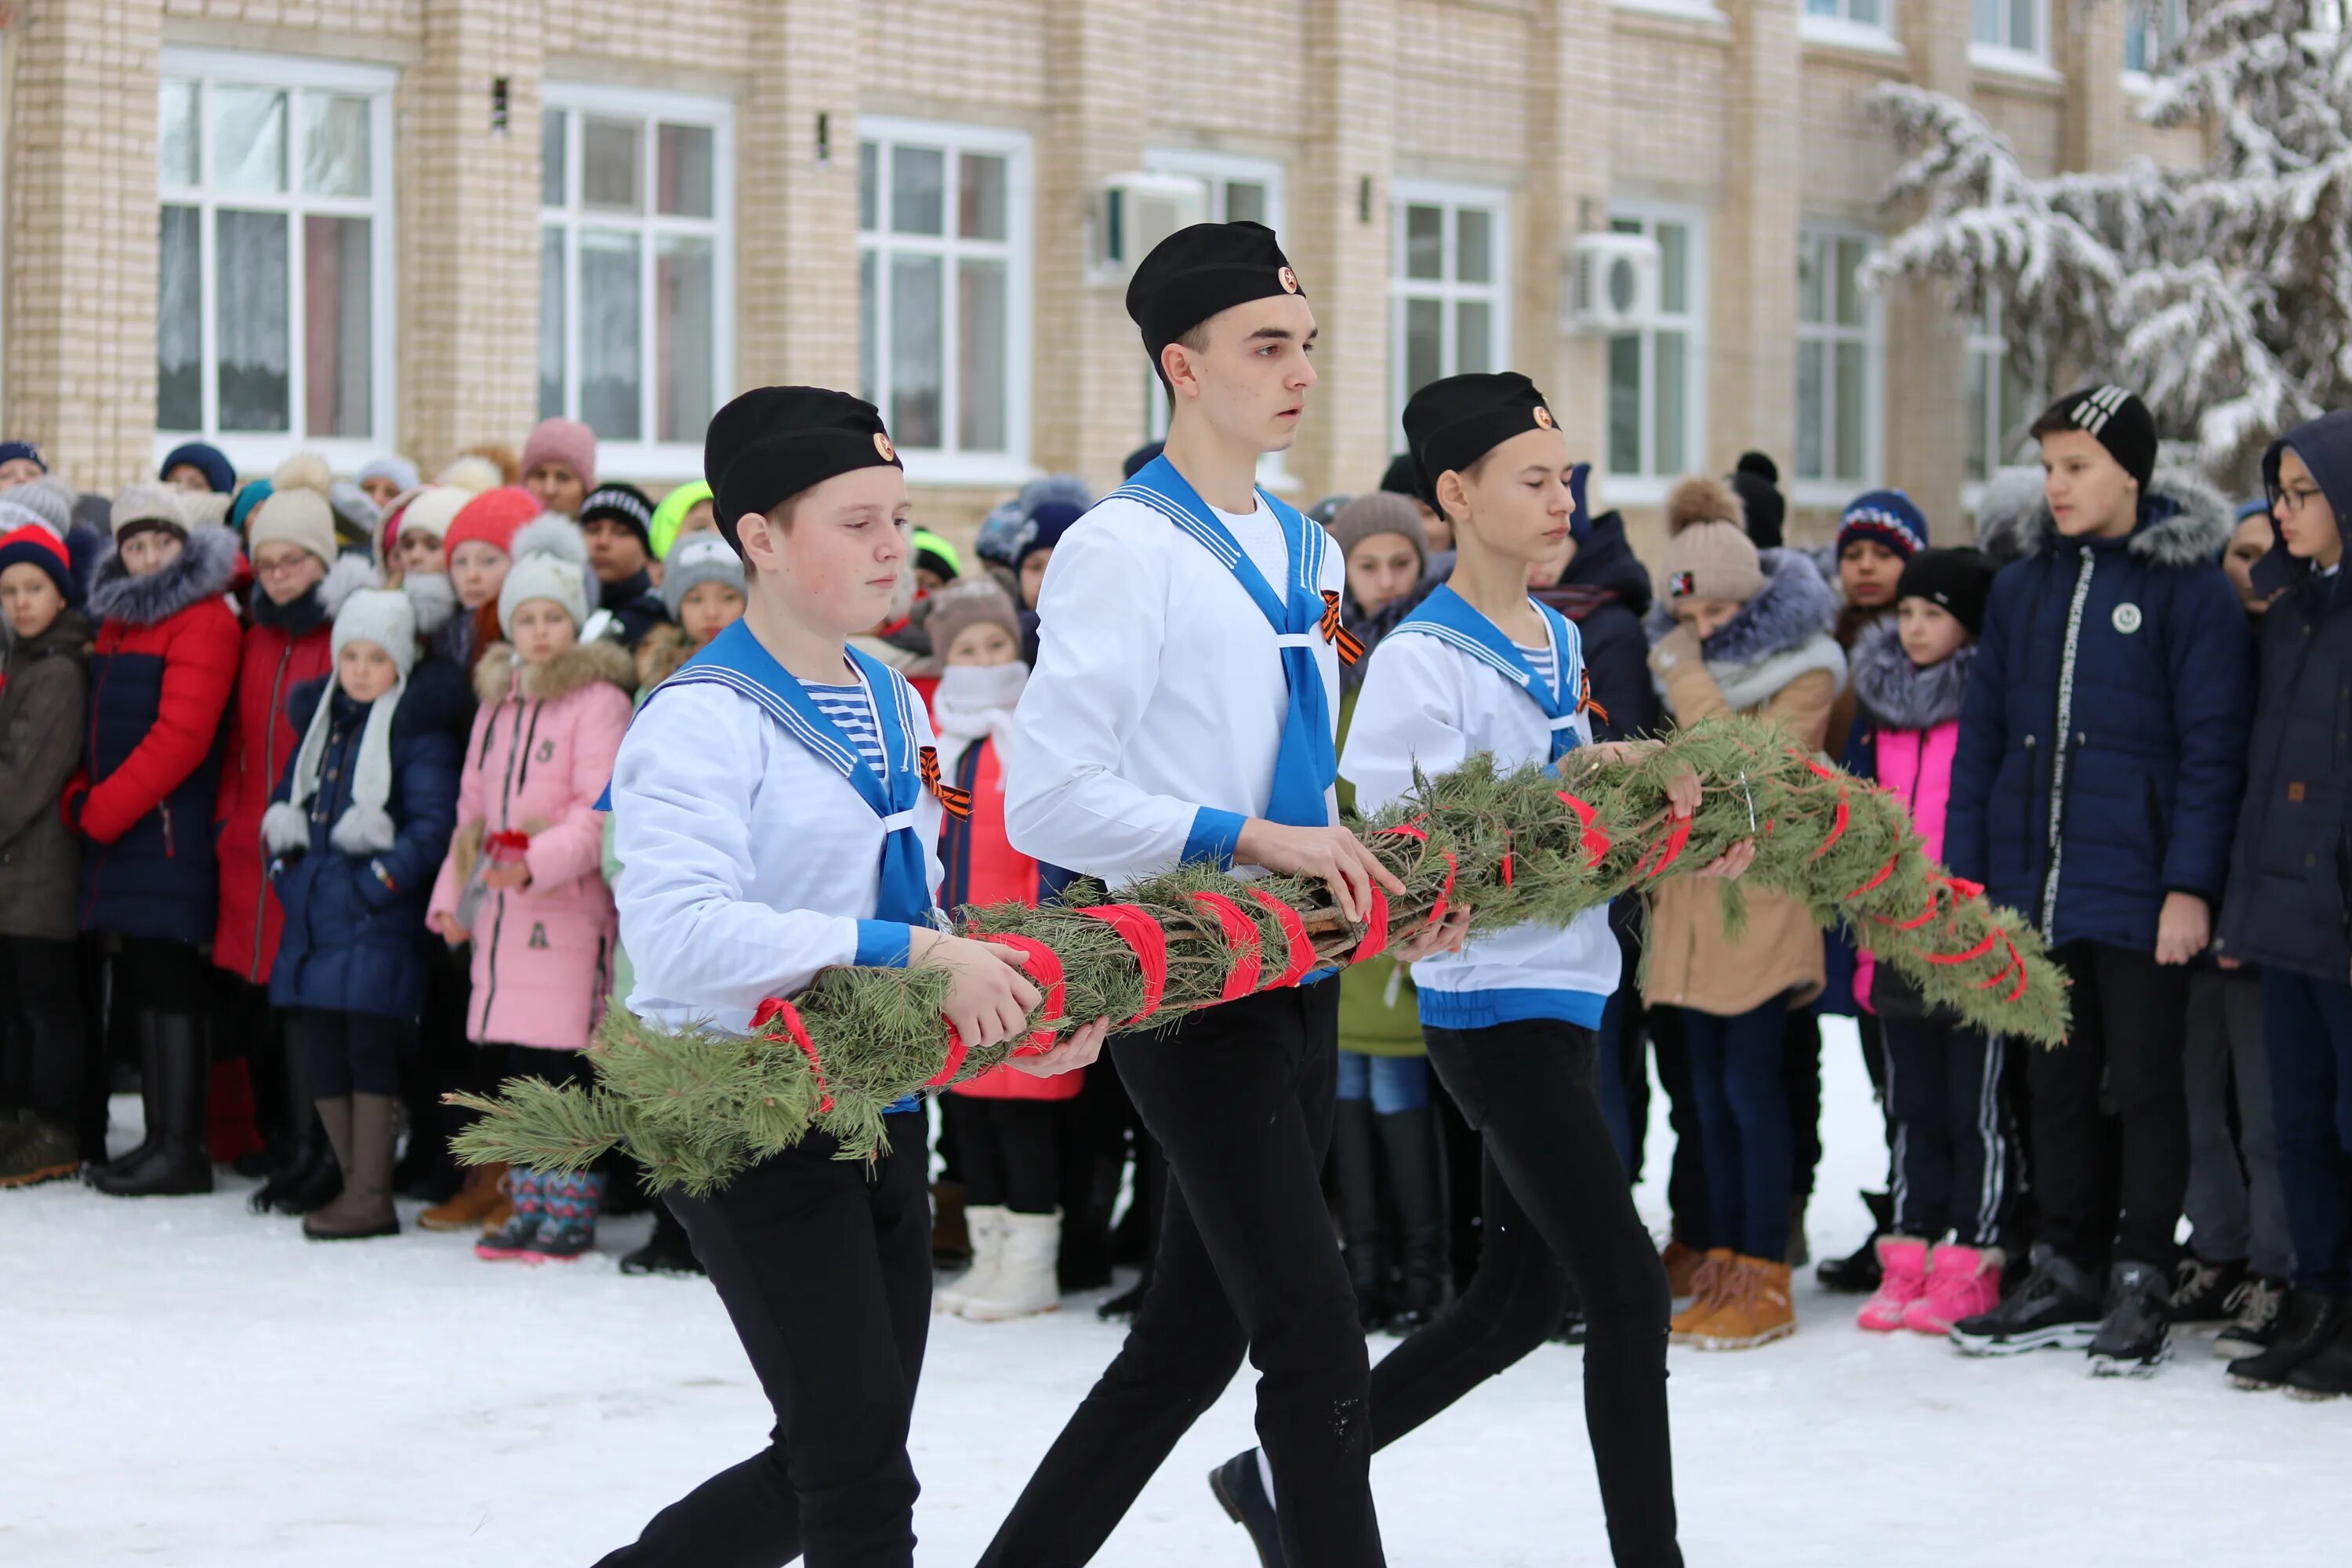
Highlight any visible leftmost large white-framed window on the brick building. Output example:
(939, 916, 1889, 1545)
(155, 49, 395, 473)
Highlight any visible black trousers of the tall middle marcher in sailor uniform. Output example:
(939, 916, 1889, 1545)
(981, 980, 1383, 1568)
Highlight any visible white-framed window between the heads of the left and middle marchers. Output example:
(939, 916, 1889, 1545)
(858, 115, 1035, 485)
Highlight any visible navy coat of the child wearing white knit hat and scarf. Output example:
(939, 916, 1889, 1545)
(270, 659, 468, 1018)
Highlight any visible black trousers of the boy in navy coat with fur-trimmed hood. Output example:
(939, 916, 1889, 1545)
(2025, 942, 2190, 1269)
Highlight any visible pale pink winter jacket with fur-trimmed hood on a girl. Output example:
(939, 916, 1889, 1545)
(430, 642, 635, 1051)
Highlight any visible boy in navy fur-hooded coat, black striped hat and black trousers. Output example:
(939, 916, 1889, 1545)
(1945, 386, 2251, 1373)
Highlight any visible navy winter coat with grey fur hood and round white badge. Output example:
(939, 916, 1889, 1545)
(1945, 473, 2253, 952)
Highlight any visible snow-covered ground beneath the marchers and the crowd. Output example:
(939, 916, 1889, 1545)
(0, 1032, 2352, 1568)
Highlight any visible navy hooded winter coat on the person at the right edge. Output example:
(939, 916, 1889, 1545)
(2213, 412, 2352, 985)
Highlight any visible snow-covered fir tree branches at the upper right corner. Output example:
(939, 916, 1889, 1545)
(1872, 0, 2352, 482)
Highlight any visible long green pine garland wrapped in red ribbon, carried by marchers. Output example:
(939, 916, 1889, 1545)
(452, 717, 2067, 1192)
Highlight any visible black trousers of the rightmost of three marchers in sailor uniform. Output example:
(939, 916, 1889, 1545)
(1383, 1020, 1682, 1568)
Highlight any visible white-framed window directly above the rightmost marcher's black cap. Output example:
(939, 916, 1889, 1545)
(1388, 179, 1510, 449)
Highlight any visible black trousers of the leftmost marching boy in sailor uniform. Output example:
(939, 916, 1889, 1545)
(600, 1112, 931, 1568)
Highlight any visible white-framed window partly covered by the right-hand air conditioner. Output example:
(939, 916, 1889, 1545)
(1604, 205, 1708, 506)
